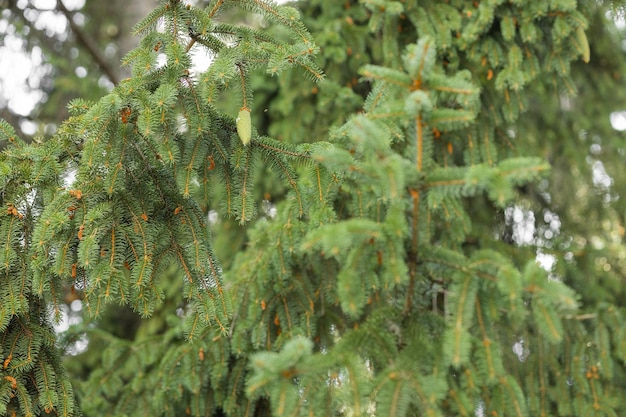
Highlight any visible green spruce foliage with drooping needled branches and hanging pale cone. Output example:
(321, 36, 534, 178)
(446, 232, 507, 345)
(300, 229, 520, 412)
(0, 0, 626, 416)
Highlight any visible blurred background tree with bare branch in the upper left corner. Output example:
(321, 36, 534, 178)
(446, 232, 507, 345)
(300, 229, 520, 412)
(0, 0, 154, 134)
